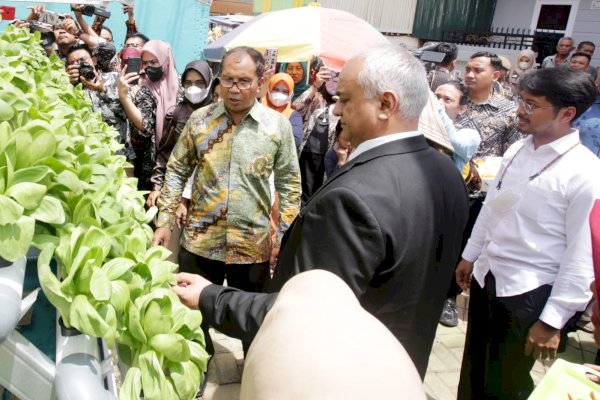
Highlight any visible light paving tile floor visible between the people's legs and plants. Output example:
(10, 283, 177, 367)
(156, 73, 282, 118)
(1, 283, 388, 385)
(202, 296, 596, 400)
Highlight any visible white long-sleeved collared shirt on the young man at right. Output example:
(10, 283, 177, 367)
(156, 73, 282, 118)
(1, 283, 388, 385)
(462, 130, 600, 328)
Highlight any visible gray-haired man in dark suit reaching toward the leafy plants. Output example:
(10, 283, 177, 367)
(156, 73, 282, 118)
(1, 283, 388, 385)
(168, 45, 467, 380)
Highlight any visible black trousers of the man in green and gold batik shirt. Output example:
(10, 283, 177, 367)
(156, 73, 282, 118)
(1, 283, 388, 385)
(178, 247, 271, 356)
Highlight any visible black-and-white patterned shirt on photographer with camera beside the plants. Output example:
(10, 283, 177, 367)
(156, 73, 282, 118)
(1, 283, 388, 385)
(84, 72, 135, 161)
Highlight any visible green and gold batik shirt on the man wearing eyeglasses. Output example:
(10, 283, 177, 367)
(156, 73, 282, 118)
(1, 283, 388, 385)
(157, 102, 302, 264)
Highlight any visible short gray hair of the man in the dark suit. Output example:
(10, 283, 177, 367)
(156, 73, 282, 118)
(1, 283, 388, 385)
(355, 45, 429, 119)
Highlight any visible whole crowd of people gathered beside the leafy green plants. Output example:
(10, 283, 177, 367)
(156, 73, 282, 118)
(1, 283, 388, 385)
(7, 4, 600, 399)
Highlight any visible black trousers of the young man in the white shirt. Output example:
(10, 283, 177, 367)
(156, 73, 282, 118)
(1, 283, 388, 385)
(457, 273, 552, 400)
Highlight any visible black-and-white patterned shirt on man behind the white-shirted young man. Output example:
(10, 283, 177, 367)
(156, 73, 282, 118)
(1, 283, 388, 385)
(457, 93, 521, 159)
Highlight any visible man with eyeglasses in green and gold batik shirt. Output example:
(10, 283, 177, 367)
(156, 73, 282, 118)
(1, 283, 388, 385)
(154, 47, 301, 354)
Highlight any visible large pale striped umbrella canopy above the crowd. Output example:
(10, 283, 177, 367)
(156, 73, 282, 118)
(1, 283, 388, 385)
(204, 6, 390, 70)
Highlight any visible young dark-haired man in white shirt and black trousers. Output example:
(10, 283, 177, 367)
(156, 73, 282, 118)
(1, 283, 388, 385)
(456, 68, 600, 399)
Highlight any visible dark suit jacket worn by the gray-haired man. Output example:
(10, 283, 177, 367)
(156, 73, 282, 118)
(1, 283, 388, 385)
(201, 136, 468, 377)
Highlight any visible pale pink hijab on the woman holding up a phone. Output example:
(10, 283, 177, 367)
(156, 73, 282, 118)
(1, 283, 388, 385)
(142, 40, 179, 143)
